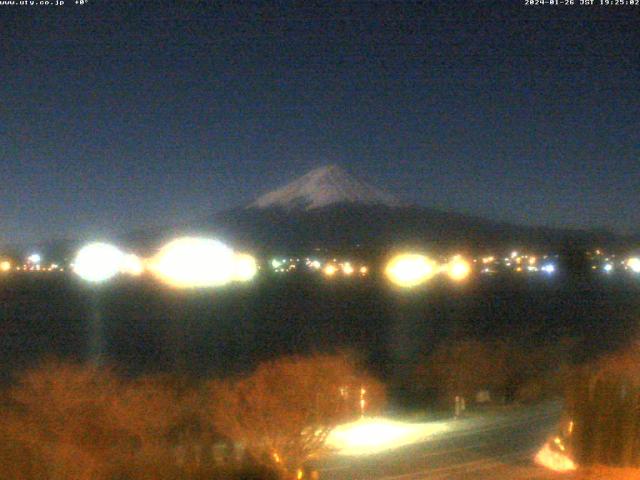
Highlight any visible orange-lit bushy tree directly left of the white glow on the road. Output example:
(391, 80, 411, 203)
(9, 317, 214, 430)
(210, 355, 384, 478)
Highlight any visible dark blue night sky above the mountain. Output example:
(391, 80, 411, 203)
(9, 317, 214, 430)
(0, 0, 640, 242)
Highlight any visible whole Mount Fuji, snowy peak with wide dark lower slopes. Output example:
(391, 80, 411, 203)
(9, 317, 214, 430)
(128, 165, 621, 254)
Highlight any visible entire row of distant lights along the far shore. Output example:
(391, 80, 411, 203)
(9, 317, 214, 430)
(36, 237, 640, 288)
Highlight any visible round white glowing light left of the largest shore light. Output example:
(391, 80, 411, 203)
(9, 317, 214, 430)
(73, 242, 124, 283)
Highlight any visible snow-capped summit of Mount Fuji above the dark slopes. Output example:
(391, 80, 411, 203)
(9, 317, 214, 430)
(249, 165, 401, 210)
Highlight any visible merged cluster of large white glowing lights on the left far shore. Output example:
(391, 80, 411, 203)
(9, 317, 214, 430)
(72, 237, 258, 288)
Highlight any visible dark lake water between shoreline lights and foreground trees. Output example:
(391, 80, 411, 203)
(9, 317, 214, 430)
(0, 274, 640, 384)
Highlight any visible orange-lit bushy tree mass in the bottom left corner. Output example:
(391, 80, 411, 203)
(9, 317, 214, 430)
(2, 361, 186, 480)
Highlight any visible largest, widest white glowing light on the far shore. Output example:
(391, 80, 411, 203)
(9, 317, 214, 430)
(149, 237, 236, 288)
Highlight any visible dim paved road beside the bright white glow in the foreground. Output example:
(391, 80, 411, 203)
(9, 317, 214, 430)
(317, 402, 561, 480)
